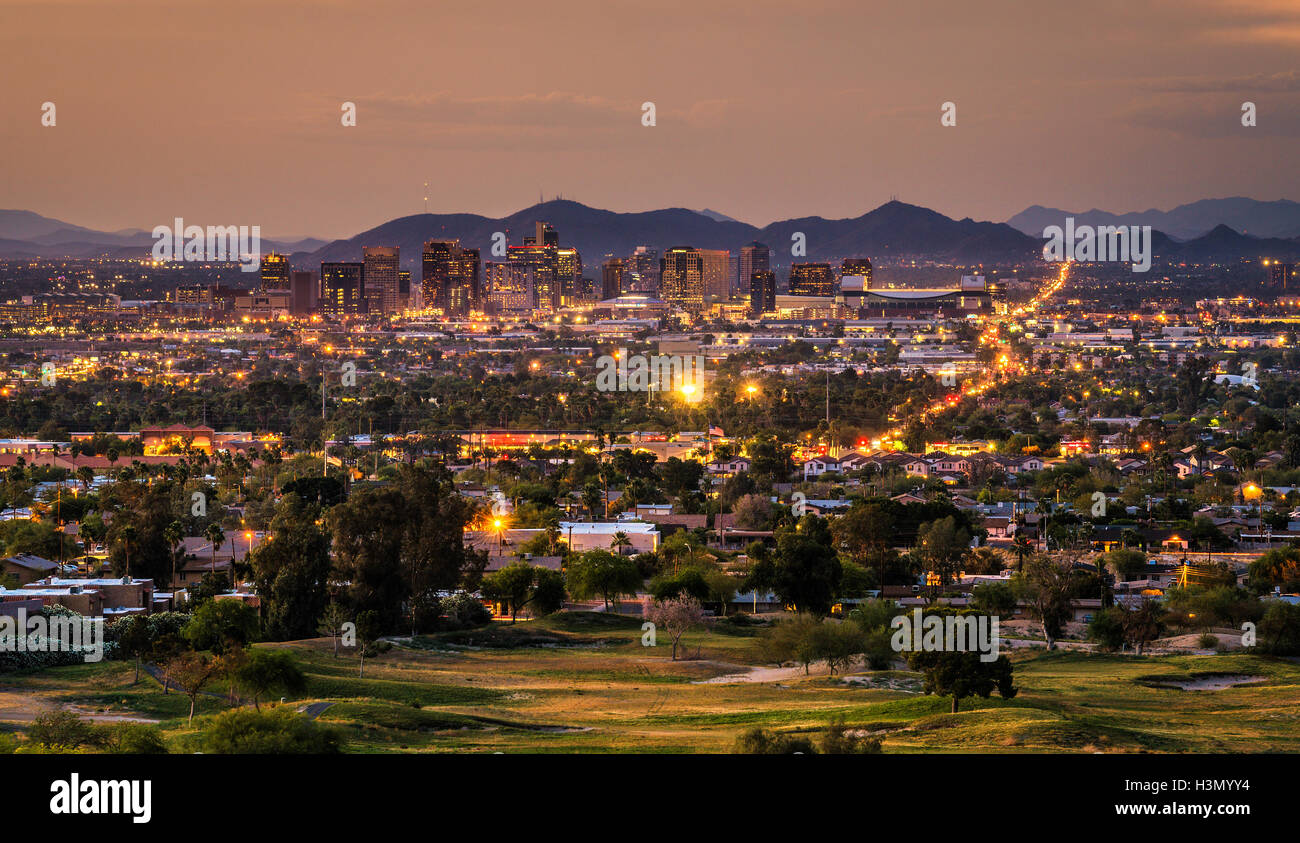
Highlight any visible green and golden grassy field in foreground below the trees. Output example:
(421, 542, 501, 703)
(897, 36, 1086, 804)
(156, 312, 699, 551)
(0, 613, 1300, 753)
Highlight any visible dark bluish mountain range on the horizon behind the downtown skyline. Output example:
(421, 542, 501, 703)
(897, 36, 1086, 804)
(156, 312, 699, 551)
(0, 199, 1300, 273)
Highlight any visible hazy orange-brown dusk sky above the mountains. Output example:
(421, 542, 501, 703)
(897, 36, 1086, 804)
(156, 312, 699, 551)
(0, 0, 1300, 238)
